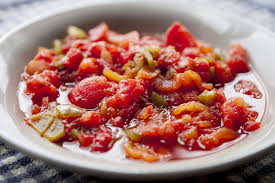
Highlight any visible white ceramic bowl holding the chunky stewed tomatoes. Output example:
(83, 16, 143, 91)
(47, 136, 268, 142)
(0, 1, 275, 180)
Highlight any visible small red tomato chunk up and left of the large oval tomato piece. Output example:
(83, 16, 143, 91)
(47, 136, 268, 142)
(62, 48, 83, 70)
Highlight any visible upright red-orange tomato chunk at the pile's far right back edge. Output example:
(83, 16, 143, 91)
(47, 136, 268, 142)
(226, 44, 249, 74)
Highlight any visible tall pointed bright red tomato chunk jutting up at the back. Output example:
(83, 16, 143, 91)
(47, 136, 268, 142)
(166, 22, 196, 52)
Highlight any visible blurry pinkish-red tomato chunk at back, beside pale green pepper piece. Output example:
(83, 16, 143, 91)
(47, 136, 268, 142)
(89, 23, 109, 41)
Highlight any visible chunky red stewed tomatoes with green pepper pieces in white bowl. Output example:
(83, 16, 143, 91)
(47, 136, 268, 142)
(18, 22, 263, 162)
